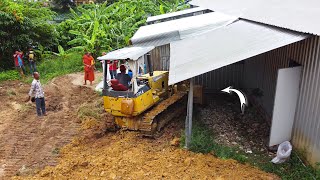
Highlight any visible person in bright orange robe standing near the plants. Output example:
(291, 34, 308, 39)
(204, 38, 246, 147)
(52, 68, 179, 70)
(82, 52, 94, 85)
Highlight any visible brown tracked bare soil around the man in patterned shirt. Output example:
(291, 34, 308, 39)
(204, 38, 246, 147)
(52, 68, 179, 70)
(0, 74, 101, 179)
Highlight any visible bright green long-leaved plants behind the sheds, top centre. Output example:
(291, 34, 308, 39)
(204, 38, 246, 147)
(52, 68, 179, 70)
(59, 0, 187, 55)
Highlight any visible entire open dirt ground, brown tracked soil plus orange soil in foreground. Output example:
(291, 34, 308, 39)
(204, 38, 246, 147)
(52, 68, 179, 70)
(0, 74, 278, 179)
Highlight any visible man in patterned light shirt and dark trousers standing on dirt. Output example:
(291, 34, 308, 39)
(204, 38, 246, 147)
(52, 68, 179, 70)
(27, 72, 47, 117)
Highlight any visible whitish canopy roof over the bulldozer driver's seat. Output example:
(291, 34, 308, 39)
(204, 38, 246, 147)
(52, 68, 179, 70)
(98, 46, 154, 60)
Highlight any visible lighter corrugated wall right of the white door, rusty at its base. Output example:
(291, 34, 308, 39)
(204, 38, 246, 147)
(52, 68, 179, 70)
(287, 37, 320, 166)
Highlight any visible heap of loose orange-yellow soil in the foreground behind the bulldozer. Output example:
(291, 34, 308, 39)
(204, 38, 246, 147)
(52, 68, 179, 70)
(15, 123, 278, 179)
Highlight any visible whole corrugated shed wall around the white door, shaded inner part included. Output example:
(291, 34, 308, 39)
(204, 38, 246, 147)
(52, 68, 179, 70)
(202, 37, 320, 163)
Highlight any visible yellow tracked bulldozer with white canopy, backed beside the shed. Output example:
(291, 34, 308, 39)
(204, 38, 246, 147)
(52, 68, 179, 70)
(98, 47, 186, 136)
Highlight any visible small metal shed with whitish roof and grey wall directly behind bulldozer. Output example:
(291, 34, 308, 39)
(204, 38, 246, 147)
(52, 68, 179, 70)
(131, 11, 238, 70)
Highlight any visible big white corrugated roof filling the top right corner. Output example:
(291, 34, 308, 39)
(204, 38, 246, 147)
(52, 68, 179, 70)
(190, 0, 320, 35)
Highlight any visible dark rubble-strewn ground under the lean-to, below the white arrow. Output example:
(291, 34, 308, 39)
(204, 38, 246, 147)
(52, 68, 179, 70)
(197, 93, 275, 157)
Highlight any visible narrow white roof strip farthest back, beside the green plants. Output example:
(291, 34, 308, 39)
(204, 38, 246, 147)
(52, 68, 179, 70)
(147, 7, 207, 23)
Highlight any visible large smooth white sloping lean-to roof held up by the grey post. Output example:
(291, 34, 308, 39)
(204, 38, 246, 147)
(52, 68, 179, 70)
(169, 20, 308, 84)
